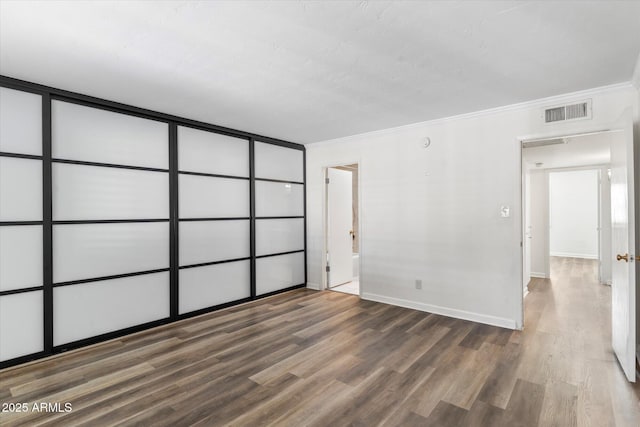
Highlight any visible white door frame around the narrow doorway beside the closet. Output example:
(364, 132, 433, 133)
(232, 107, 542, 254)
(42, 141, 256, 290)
(320, 159, 364, 295)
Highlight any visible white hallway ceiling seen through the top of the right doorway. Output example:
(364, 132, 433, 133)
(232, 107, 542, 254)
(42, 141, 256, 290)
(522, 132, 620, 169)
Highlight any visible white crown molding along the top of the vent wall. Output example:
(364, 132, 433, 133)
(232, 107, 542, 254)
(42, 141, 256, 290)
(305, 82, 638, 148)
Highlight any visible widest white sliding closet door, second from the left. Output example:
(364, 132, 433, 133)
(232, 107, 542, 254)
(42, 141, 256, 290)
(52, 101, 170, 346)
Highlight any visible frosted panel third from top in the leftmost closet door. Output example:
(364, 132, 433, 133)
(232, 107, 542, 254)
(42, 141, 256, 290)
(0, 225, 42, 291)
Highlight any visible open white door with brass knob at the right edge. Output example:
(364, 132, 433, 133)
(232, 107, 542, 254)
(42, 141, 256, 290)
(611, 110, 636, 382)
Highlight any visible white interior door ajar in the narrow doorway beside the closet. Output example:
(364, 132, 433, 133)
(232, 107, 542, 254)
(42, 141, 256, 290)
(327, 168, 353, 287)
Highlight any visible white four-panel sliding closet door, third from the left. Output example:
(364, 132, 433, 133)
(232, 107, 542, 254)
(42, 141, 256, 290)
(178, 126, 251, 314)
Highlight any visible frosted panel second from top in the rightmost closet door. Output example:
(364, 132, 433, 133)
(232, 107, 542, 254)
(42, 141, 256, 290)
(256, 181, 304, 216)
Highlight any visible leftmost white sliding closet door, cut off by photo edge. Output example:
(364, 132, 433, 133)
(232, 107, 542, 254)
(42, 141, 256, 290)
(0, 87, 44, 362)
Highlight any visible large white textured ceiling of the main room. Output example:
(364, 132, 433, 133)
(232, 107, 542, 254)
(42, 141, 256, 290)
(0, 1, 640, 143)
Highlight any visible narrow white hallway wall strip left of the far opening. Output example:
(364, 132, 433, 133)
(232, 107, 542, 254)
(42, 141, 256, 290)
(530, 170, 549, 278)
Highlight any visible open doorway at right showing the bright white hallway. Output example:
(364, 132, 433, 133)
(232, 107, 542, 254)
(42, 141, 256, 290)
(522, 132, 611, 295)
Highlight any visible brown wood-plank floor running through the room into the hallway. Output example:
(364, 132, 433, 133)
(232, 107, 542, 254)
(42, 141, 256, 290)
(0, 258, 640, 427)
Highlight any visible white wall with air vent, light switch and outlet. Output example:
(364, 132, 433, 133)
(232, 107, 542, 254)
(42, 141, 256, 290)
(307, 84, 637, 328)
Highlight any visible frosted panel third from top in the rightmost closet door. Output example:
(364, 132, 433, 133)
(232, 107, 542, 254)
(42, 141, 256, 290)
(256, 218, 304, 256)
